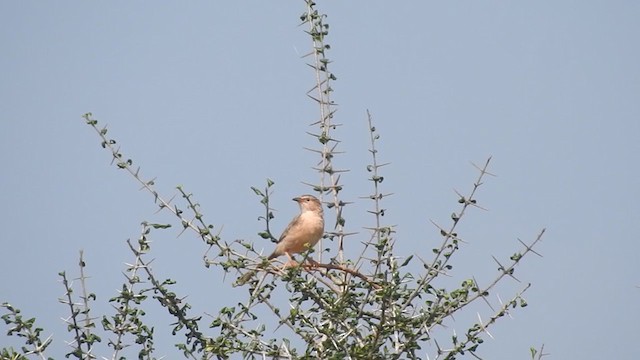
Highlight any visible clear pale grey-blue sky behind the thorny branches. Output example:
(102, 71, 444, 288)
(0, 1, 640, 359)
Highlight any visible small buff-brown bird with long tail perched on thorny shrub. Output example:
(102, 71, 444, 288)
(235, 195, 324, 286)
